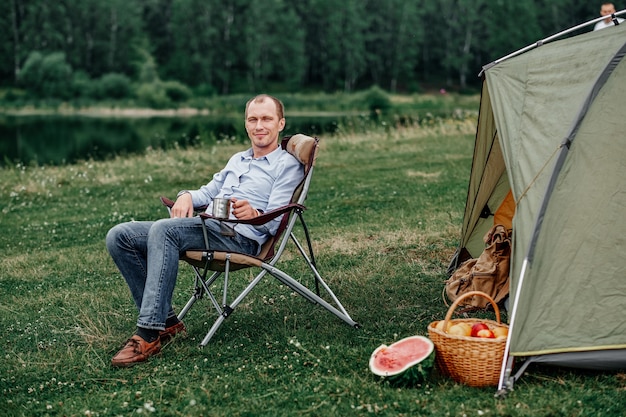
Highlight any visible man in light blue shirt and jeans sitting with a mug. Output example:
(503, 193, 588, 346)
(106, 95, 304, 366)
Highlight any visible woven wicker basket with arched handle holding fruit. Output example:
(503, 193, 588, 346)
(428, 291, 508, 387)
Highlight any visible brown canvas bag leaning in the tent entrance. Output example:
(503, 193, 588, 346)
(445, 224, 511, 309)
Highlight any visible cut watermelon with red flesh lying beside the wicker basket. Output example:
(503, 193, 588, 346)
(370, 336, 435, 385)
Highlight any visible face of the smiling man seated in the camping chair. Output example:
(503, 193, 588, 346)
(246, 99, 285, 157)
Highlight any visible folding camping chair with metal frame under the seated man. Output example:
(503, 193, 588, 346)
(161, 134, 359, 346)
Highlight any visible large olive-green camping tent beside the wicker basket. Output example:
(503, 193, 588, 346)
(450, 20, 626, 390)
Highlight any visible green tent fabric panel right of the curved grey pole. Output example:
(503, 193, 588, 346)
(511, 40, 626, 356)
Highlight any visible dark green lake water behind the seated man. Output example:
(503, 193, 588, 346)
(0, 115, 370, 166)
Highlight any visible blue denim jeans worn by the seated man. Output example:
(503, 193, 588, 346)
(106, 217, 258, 330)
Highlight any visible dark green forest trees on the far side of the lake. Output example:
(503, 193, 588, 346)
(0, 0, 608, 103)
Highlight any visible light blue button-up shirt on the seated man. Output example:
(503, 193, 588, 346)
(189, 146, 304, 245)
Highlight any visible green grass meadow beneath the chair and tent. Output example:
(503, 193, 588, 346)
(0, 120, 626, 416)
